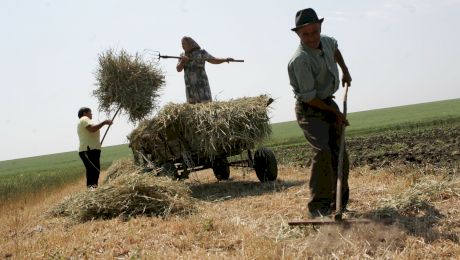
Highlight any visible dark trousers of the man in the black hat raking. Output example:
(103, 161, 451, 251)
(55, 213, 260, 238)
(296, 98, 350, 214)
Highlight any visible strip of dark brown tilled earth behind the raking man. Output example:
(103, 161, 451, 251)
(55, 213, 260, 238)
(274, 125, 460, 171)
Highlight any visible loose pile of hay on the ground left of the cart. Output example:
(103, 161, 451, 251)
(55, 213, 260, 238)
(49, 168, 194, 222)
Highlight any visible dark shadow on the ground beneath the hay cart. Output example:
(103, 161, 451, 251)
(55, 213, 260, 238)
(190, 180, 306, 201)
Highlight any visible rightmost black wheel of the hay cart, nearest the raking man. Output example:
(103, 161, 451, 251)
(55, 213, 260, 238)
(254, 147, 278, 182)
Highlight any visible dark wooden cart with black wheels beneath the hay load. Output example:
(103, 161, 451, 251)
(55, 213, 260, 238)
(133, 122, 278, 182)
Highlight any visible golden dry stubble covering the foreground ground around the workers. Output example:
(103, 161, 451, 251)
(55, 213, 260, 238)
(0, 167, 460, 259)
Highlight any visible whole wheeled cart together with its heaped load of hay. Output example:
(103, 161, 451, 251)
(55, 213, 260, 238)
(128, 95, 277, 181)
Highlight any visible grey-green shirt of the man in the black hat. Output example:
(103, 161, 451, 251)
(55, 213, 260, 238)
(288, 35, 340, 102)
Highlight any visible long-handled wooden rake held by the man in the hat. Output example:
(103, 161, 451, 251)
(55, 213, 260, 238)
(288, 85, 371, 226)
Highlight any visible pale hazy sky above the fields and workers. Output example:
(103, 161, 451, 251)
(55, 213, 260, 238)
(0, 0, 460, 160)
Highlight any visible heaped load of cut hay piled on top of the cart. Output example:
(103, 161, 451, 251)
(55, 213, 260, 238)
(128, 95, 271, 161)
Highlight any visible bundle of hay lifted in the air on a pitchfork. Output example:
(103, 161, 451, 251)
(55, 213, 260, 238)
(93, 50, 165, 122)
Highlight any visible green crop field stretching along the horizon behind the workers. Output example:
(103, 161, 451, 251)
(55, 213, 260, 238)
(0, 99, 460, 200)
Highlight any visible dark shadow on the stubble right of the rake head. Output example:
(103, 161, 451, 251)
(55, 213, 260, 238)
(361, 202, 460, 243)
